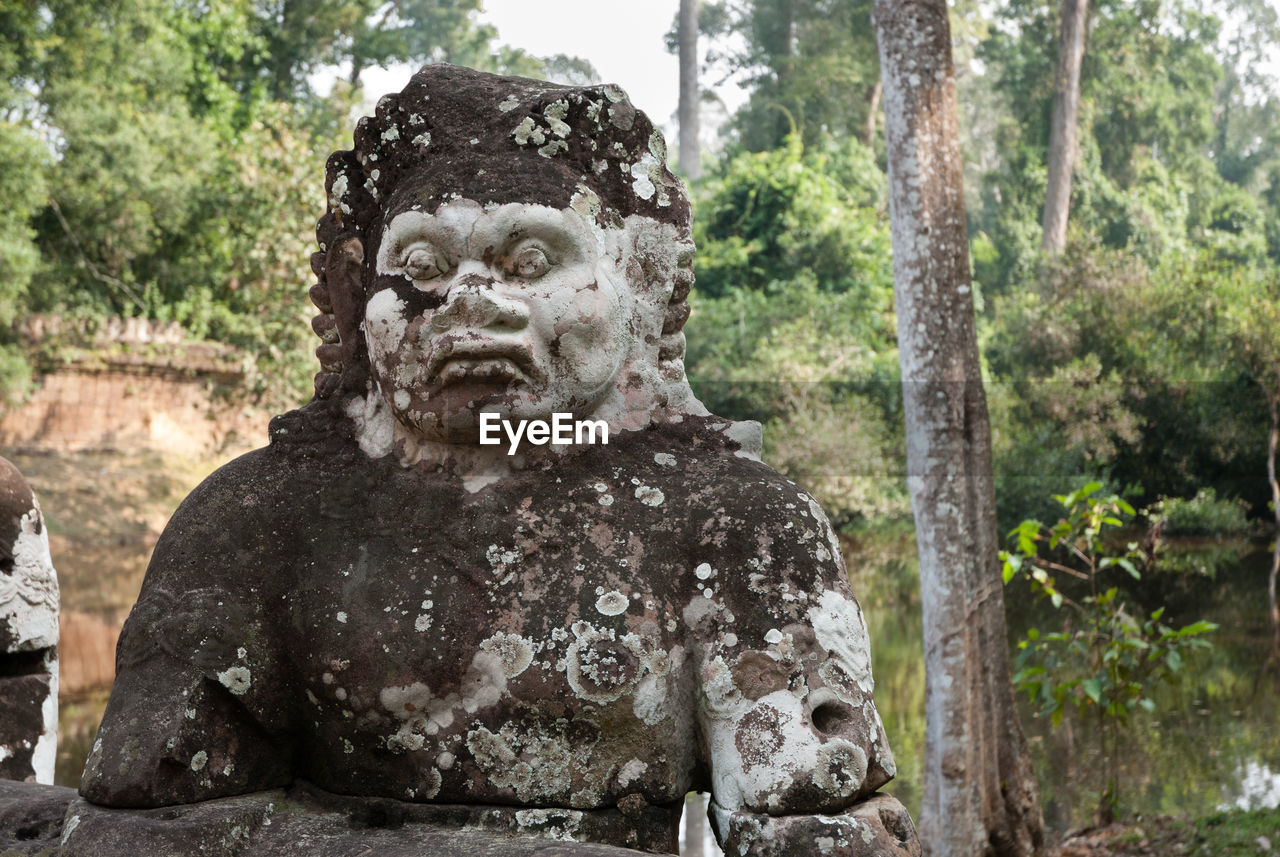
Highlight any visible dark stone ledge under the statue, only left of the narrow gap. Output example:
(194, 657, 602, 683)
(0, 782, 680, 857)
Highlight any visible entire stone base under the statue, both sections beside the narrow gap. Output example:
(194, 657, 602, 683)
(0, 780, 920, 857)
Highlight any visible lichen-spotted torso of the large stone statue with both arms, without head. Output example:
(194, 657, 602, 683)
(82, 421, 892, 839)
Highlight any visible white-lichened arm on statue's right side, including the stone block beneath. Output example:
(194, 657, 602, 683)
(696, 485, 918, 857)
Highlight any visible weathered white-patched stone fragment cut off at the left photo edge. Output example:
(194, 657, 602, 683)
(0, 458, 58, 783)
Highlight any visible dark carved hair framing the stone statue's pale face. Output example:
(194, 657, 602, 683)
(311, 64, 694, 399)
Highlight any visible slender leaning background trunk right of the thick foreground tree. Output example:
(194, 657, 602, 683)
(1041, 0, 1089, 253)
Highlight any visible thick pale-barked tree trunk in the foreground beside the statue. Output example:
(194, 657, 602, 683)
(874, 0, 1044, 857)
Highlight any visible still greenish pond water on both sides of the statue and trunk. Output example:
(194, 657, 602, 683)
(58, 533, 1280, 833)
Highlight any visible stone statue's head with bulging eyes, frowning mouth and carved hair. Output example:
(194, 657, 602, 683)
(312, 65, 705, 452)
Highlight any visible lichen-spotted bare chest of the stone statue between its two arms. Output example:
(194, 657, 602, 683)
(282, 493, 698, 808)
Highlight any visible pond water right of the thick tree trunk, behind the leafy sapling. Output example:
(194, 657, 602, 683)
(1010, 540, 1280, 828)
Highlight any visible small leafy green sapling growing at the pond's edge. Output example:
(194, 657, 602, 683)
(1001, 482, 1217, 824)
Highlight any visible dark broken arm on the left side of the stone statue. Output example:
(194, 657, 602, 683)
(81, 460, 292, 807)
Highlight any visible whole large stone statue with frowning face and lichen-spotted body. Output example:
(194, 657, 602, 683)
(63, 65, 918, 857)
